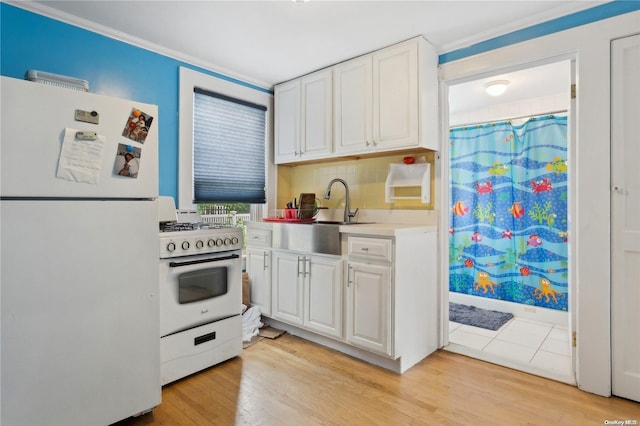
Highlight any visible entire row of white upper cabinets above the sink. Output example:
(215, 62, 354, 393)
(275, 37, 439, 164)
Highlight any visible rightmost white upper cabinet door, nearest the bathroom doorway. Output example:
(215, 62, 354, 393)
(373, 40, 419, 149)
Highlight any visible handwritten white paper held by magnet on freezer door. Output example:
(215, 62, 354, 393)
(56, 128, 106, 184)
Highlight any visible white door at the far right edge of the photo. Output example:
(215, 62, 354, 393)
(611, 35, 640, 401)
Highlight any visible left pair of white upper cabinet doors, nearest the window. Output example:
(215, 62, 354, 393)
(274, 69, 333, 164)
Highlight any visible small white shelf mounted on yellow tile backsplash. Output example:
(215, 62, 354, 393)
(384, 163, 431, 204)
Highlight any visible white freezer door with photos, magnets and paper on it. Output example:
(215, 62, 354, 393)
(0, 76, 159, 199)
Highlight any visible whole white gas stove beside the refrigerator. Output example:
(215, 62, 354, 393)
(159, 197, 242, 385)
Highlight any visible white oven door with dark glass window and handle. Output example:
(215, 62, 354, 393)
(160, 250, 242, 337)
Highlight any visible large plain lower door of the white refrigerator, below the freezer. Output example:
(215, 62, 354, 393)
(0, 200, 161, 425)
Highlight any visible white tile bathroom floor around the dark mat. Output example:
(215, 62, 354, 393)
(445, 317, 575, 384)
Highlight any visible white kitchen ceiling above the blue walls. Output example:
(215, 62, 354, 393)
(21, 0, 606, 111)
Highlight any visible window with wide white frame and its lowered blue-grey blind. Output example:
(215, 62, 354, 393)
(176, 67, 275, 216)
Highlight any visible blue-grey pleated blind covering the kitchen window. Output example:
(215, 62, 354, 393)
(193, 88, 266, 204)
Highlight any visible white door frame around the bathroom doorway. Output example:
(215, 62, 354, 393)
(439, 12, 640, 396)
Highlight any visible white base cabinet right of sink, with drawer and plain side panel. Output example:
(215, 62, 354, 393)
(346, 231, 439, 371)
